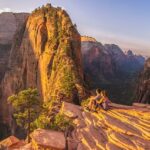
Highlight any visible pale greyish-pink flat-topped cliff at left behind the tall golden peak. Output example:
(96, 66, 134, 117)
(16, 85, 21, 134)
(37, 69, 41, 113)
(0, 12, 28, 81)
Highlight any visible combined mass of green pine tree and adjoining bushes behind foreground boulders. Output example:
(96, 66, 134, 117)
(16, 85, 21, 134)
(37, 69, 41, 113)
(8, 88, 73, 142)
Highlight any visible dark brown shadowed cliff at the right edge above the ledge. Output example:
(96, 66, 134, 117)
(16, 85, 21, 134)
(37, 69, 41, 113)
(137, 58, 150, 104)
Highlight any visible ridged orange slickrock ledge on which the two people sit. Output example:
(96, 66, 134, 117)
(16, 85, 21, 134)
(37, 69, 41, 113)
(63, 103, 150, 150)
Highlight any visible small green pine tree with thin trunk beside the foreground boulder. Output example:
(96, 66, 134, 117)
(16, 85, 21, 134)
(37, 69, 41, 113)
(8, 88, 42, 142)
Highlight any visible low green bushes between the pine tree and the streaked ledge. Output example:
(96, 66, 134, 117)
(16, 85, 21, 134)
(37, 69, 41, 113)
(34, 100, 73, 132)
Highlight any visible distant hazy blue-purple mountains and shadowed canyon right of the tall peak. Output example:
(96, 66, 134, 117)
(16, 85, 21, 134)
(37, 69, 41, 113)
(81, 37, 145, 104)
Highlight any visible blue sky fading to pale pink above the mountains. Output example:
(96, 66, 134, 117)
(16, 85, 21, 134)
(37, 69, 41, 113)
(0, 0, 150, 56)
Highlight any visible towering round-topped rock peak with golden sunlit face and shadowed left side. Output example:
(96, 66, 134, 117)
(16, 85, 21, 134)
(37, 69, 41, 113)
(1, 5, 85, 123)
